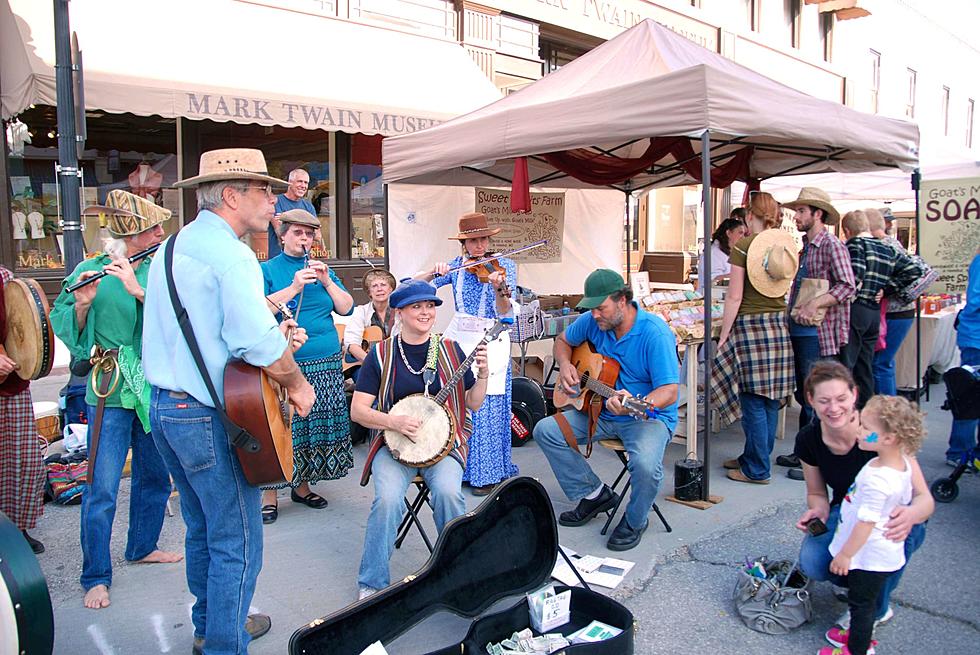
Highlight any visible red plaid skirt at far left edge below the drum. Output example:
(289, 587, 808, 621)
(0, 389, 45, 530)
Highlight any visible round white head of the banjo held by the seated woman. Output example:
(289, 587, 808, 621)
(384, 394, 456, 468)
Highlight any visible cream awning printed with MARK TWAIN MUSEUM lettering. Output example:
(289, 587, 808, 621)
(0, 0, 500, 135)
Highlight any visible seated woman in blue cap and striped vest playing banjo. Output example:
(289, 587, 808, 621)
(351, 280, 490, 598)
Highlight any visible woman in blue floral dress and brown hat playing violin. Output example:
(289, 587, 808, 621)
(416, 213, 517, 496)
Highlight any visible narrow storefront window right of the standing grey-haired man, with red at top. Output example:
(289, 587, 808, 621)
(350, 134, 385, 259)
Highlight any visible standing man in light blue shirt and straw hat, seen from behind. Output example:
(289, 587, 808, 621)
(143, 148, 315, 653)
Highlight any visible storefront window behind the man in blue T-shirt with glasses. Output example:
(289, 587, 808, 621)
(195, 121, 336, 260)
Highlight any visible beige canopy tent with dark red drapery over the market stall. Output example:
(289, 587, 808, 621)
(382, 20, 919, 500)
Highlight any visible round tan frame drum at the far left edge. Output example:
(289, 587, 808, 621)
(3, 278, 54, 380)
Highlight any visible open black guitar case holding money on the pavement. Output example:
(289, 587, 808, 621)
(289, 477, 633, 655)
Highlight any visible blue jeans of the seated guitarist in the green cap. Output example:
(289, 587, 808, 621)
(534, 410, 670, 529)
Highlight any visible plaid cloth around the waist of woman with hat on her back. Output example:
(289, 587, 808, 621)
(711, 312, 796, 427)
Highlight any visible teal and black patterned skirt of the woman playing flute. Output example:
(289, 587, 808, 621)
(267, 353, 354, 489)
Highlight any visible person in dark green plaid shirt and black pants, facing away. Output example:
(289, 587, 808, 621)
(840, 211, 898, 409)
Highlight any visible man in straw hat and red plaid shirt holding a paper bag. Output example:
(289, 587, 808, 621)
(777, 187, 855, 456)
